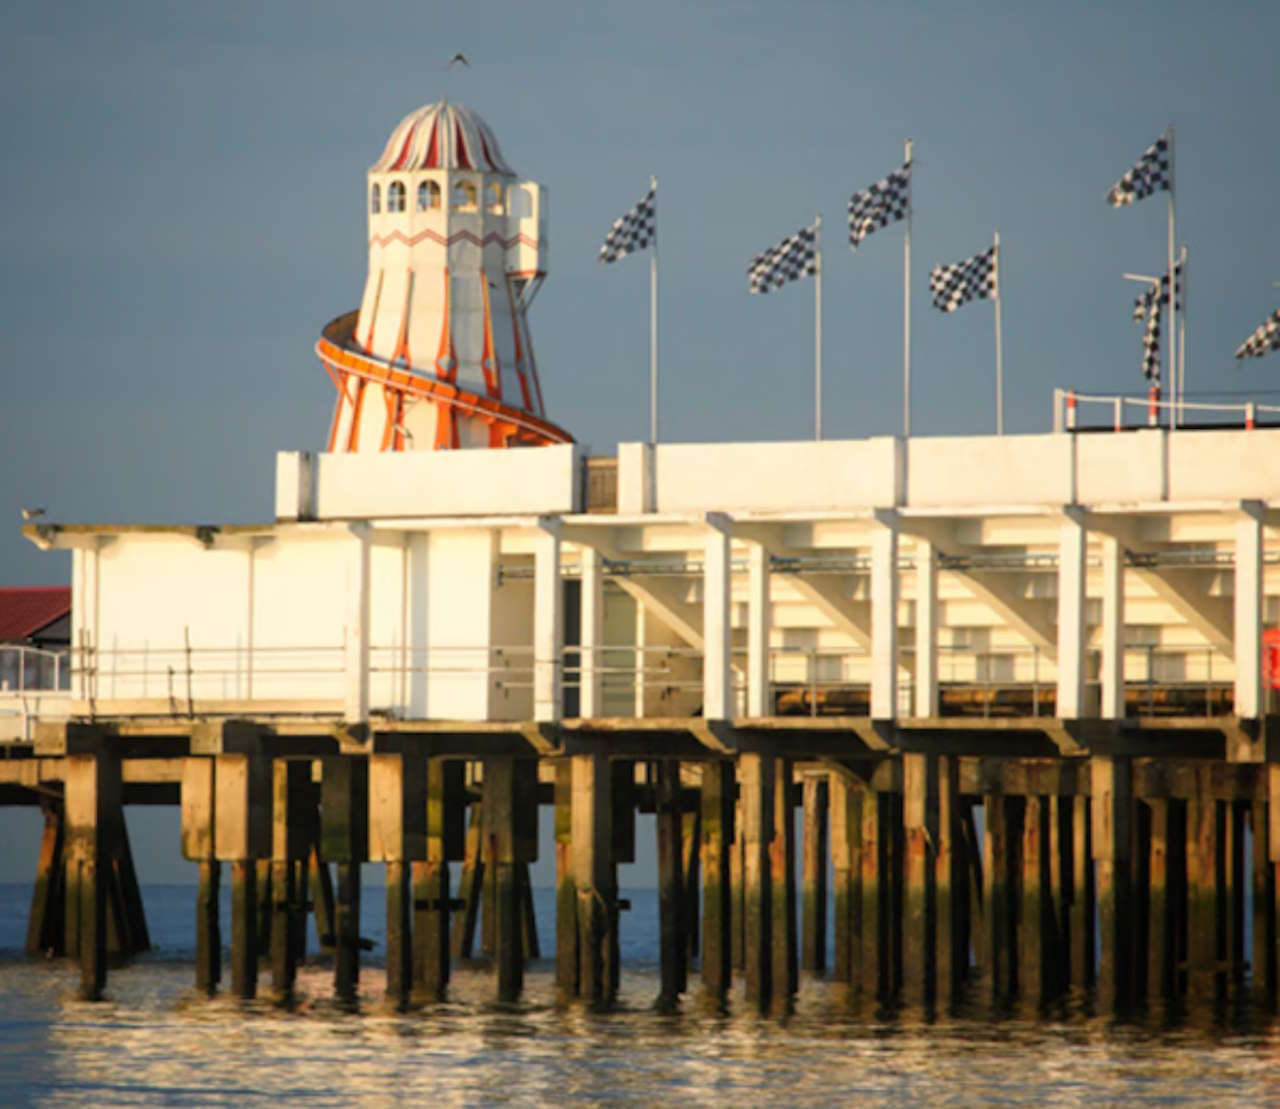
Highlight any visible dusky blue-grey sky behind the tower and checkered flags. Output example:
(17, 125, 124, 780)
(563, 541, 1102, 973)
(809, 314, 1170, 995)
(0, 0, 1280, 875)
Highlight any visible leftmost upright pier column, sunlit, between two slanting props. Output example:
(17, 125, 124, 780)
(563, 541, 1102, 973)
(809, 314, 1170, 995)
(64, 741, 124, 1001)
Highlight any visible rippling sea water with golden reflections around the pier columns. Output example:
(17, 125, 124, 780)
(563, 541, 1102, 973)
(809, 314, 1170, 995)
(0, 885, 1280, 1106)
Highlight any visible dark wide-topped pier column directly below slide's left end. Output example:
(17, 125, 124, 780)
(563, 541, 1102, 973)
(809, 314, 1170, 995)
(320, 754, 369, 1004)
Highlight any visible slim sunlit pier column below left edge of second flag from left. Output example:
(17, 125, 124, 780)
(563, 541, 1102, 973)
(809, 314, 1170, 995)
(739, 754, 773, 1012)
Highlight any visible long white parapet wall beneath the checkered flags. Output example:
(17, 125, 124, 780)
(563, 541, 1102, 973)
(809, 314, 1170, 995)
(618, 428, 1280, 515)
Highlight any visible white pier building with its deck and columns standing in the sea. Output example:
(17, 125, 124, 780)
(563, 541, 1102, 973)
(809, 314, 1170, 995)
(0, 429, 1280, 1014)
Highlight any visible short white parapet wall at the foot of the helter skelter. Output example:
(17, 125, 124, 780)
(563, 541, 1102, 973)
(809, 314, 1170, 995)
(275, 443, 581, 521)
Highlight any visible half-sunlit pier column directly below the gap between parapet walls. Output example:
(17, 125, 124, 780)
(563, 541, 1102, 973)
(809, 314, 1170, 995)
(571, 754, 618, 1007)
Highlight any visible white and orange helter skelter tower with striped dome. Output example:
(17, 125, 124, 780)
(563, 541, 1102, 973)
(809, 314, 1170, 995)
(316, 100, 572, 451)
